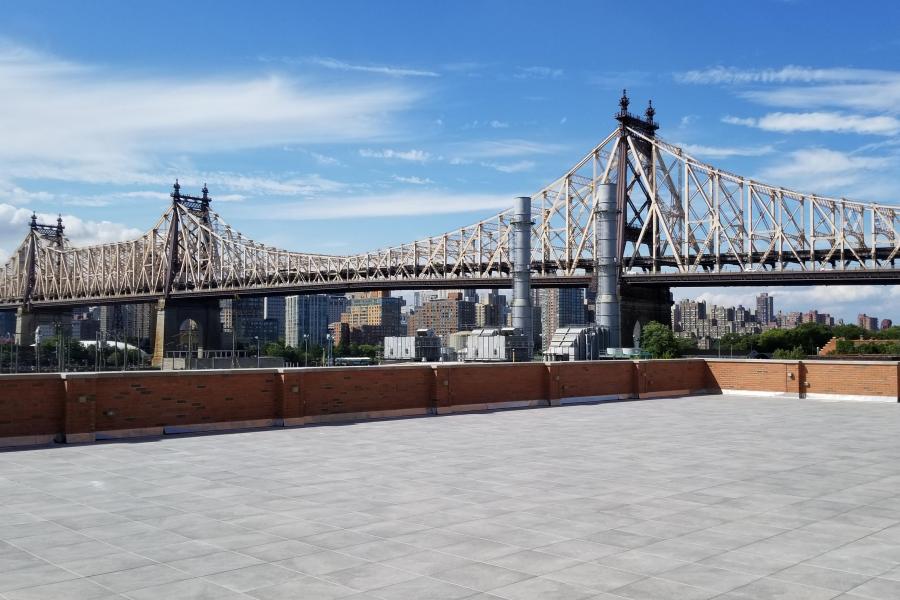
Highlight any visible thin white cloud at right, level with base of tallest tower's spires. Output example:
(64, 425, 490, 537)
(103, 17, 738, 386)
(722, 112, 900, 135)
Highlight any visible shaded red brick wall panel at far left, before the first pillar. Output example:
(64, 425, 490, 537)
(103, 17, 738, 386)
(0, 375, 66, 437)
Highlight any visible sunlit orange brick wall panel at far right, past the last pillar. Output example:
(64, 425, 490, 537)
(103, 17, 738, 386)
(804, 362, 898, 398)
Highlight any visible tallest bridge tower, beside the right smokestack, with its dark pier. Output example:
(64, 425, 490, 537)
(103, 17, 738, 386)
(616, 90, 672, 347)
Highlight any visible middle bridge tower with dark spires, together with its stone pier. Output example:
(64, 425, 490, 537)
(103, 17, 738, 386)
(151, 179, 221, 367)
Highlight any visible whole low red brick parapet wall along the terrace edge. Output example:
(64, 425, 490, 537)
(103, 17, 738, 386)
(0, 359, 900, 446)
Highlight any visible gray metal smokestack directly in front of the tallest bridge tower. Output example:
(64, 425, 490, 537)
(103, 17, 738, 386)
(597, 183, 622, 348)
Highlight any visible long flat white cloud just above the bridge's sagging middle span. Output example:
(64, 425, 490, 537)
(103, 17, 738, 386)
(242, 191, 514, 220)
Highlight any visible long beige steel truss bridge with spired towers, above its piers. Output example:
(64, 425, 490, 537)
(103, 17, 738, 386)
(0, 94, 900, 310)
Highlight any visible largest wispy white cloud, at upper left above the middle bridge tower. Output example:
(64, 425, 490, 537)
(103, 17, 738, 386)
(0, 44, 419, 184)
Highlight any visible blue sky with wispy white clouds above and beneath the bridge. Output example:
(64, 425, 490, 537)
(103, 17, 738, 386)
(0, 0, 900, 318)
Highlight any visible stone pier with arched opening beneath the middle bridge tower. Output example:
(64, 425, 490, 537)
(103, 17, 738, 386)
(151, 298, 222, 367)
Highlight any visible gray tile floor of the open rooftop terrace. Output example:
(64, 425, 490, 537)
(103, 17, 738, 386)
(0, 396, 900, 600)
